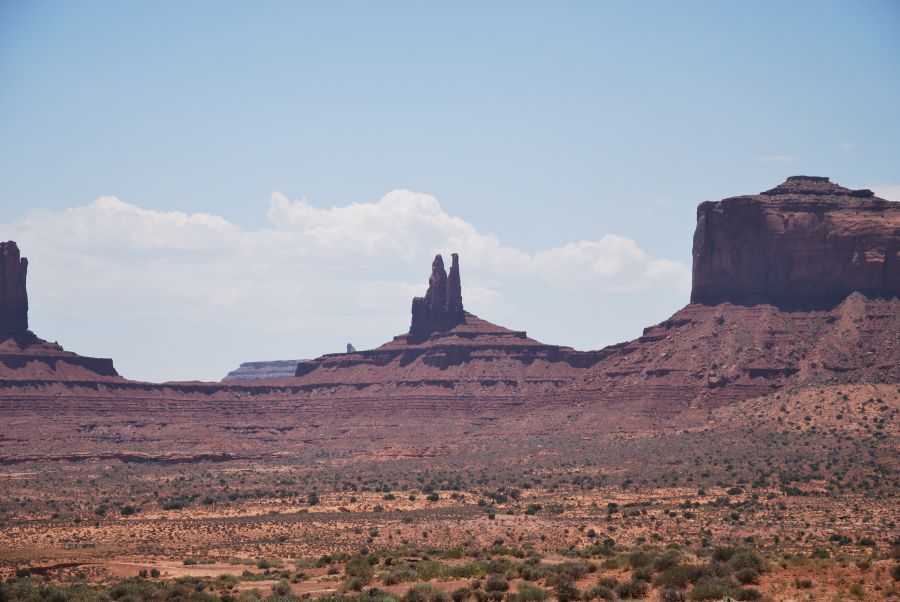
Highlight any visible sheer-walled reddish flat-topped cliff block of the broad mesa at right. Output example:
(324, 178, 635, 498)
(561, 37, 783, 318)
(691, 176, 900, 309)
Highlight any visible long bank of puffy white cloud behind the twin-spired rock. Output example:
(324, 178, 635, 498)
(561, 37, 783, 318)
(0, 190, 690, 378)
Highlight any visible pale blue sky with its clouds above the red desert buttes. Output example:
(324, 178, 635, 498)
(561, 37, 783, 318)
(0, 0, 900, 380)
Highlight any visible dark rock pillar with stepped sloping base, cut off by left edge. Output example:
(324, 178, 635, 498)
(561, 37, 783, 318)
(0, 241, 119, 381)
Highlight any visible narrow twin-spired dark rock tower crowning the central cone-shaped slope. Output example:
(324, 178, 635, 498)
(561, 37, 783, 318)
(409, 253, 466, 342)
